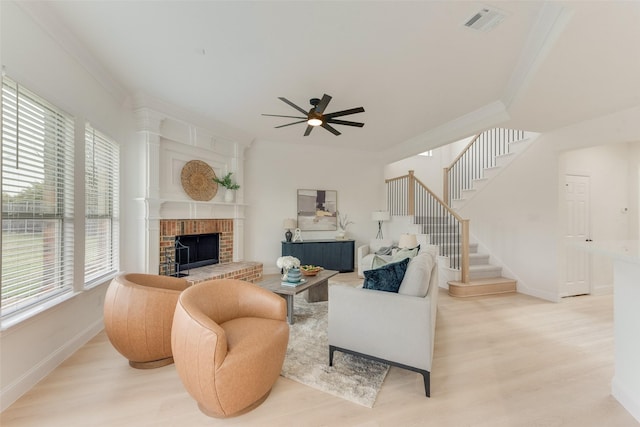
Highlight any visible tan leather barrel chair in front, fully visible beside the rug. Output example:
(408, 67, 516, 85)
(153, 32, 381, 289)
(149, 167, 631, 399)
(171, 279, 289, 418)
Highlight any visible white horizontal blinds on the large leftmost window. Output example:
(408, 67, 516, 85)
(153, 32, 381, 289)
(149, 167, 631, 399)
(0, 77, 74, 317)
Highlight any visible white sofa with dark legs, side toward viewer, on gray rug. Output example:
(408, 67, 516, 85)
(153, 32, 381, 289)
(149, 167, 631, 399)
(328, 245, 438, 396)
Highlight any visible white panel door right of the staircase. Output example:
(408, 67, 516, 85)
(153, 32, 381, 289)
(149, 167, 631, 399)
(561, 175, 591, 297)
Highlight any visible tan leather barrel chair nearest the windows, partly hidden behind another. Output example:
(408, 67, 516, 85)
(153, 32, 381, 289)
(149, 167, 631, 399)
(104, 273, 189, 369)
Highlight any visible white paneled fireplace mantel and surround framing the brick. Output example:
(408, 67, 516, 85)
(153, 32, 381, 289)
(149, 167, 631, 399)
(136, 107, 247, 274)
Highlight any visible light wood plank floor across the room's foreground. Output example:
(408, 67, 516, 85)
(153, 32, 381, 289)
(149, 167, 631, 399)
(0, 278, 640, 427)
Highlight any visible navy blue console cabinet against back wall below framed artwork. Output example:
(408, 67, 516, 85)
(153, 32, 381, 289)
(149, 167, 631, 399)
(282, 240, 355, 273)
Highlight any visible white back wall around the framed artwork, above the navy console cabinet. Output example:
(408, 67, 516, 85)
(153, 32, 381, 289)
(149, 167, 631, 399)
(244, 140, 385, 273)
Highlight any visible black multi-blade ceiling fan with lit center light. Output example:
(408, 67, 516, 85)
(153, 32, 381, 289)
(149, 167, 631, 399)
(263, 93, 364, 136)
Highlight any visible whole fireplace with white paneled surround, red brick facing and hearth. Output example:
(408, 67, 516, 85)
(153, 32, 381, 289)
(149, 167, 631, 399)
(132, 105, 255, 281)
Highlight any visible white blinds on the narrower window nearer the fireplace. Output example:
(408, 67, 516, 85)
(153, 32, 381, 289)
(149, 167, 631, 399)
(84, 124, 119, 285)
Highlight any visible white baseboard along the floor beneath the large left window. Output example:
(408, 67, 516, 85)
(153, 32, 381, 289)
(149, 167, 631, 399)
(0, 318, 104, 412)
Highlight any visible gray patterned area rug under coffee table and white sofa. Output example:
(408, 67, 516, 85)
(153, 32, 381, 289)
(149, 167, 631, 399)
(282, 295, 389, 408)
